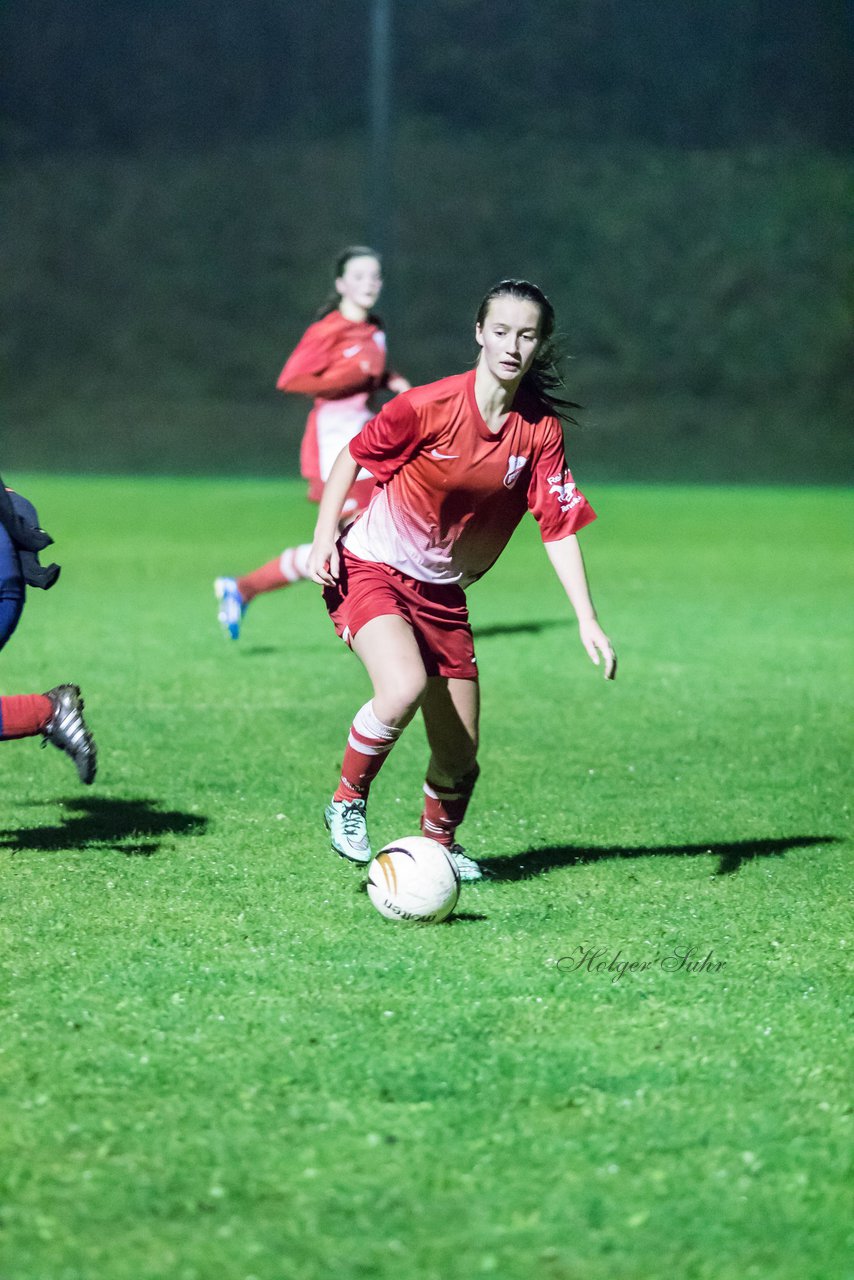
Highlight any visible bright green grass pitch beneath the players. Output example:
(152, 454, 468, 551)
(0, 475, 854, 1280)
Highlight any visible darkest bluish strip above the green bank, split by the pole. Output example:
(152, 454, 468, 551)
(0, 0, 854, 155)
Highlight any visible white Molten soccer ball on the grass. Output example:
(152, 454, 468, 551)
(367, 836, 460, 924)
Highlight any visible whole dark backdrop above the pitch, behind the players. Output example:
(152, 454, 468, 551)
(0, 0, 854, 483)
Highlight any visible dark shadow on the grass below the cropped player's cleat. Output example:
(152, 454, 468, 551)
(0, 796, 207, 858)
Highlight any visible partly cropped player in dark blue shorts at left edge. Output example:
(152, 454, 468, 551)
(0, 480, 97, 783)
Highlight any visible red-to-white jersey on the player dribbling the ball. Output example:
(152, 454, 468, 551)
(344, 370, 595, 586)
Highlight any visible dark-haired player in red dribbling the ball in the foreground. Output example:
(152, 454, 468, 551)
(309, 280, 617, 881)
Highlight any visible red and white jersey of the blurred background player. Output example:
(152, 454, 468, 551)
(275, 311, 388, 480)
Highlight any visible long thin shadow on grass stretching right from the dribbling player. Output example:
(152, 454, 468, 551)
(478, 836, 840, 881)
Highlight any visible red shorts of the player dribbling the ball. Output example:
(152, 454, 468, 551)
(323, 544, 478, 680)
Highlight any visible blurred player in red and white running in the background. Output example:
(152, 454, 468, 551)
(214, 244, 410, 640)
